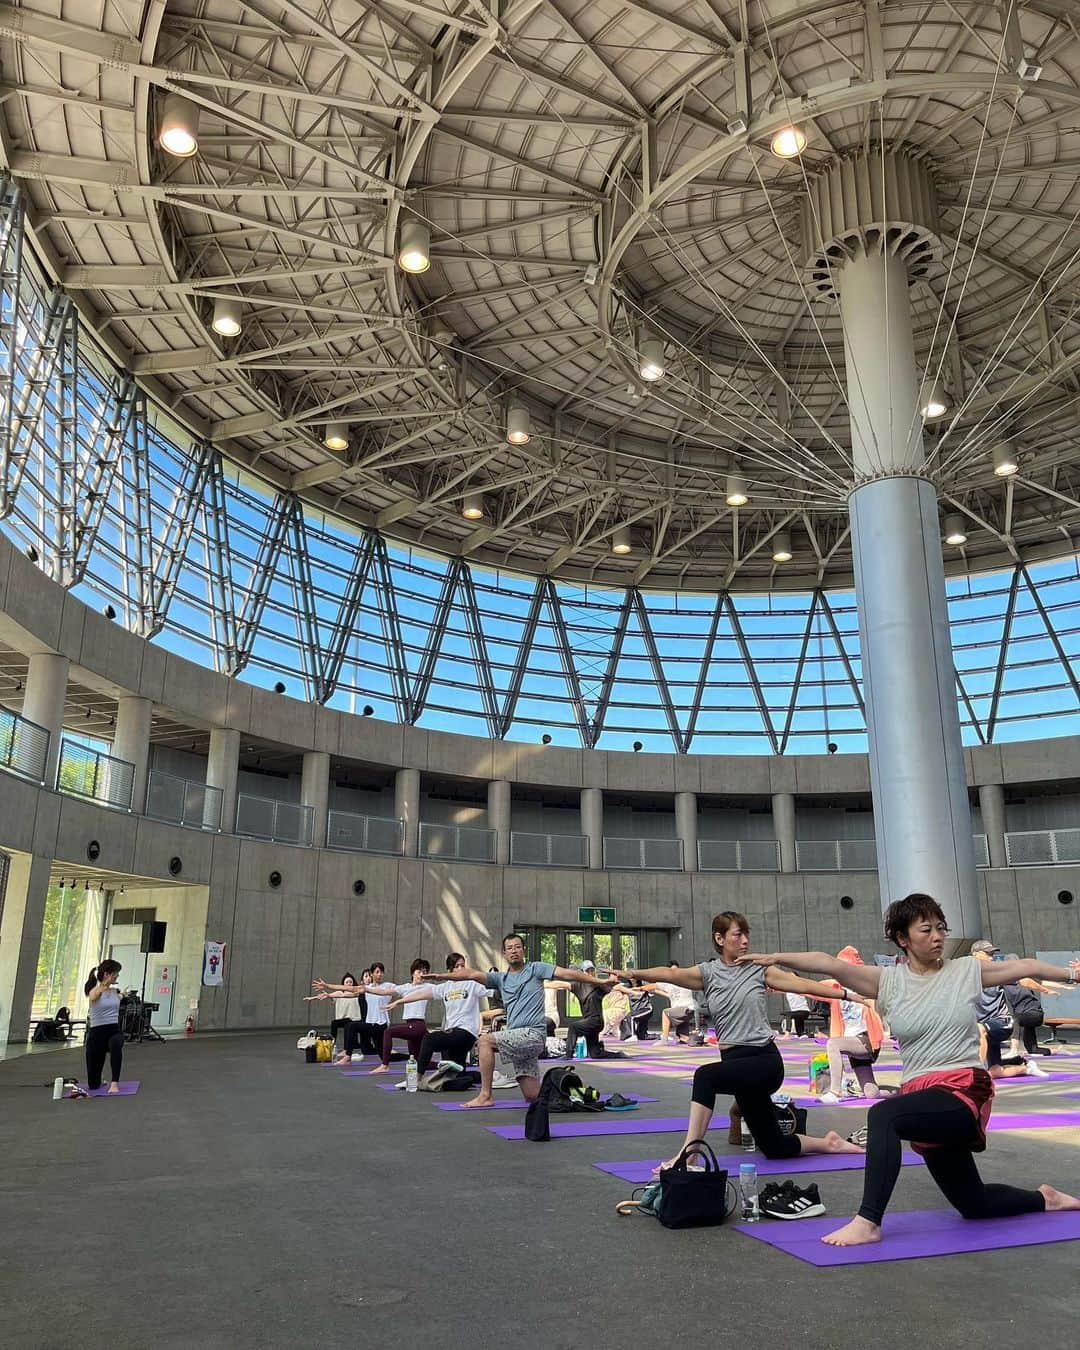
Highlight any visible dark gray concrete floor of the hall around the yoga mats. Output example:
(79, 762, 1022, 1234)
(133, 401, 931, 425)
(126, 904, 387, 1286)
(0, 1033, 1080, 1350)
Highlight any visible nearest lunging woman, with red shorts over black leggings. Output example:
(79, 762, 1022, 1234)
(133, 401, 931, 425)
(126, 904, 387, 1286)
(741, 894, 1080, 1247)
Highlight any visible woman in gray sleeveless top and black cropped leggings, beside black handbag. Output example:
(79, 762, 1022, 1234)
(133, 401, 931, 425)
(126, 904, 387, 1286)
(618, 910, 863, 1170)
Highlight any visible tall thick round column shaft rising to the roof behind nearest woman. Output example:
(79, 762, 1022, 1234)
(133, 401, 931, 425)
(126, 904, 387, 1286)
(836, 251, 981, 938)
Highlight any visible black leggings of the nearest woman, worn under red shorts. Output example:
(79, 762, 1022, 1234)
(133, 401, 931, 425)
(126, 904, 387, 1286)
(859, 1088, 1046, 1223)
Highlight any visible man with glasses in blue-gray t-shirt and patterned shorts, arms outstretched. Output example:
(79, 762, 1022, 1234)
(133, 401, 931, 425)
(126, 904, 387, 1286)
(431, 933, 617, 1106)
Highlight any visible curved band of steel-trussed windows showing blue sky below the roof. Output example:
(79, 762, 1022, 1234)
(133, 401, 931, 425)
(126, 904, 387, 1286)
(0, 189, 1080, 753)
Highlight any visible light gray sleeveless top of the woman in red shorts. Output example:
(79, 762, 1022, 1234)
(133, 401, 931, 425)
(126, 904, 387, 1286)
(878, 956, 983, 1083)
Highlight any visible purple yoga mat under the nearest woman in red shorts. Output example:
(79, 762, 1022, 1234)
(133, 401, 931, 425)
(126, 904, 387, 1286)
(736, 1210, 1080, 1266)
